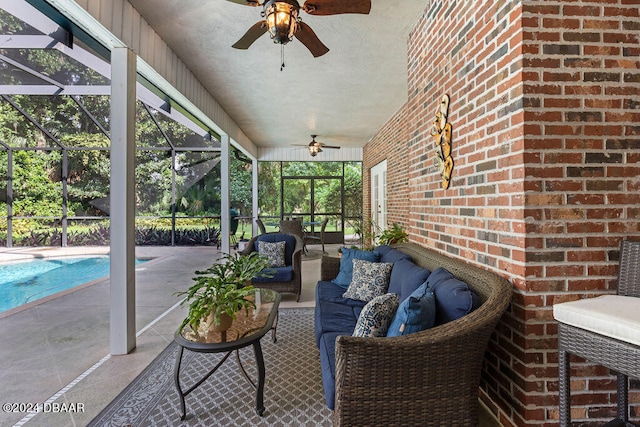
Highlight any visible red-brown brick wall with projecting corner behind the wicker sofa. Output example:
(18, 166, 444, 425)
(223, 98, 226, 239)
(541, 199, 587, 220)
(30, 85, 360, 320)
(364, 0, 640, 426)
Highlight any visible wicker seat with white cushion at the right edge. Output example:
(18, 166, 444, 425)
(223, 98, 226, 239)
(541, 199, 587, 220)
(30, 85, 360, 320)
(553, 240, 640, 427)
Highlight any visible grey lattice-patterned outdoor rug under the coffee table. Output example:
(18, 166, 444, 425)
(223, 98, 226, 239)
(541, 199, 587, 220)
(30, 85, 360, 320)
(89, 309, 332, 427)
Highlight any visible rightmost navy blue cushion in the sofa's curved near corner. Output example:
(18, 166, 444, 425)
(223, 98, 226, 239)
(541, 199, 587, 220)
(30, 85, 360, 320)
(427, 267, 481, 325)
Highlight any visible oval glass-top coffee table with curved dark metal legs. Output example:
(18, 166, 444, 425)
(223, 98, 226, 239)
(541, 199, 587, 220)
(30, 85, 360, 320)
(173, 289, 280, 420)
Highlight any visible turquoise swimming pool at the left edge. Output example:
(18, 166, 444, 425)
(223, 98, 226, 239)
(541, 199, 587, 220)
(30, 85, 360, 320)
(0, 255, 147, 313)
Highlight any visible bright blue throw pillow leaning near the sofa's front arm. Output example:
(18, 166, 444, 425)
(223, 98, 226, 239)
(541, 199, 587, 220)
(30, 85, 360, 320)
(387, 282, 436, 337)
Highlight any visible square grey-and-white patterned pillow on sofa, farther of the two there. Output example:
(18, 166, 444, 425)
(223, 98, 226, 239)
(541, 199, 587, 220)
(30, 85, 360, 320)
(342, 259, 393, 302)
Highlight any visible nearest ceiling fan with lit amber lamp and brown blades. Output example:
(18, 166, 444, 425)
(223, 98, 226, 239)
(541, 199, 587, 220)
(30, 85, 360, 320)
(228, 0, 371, 57)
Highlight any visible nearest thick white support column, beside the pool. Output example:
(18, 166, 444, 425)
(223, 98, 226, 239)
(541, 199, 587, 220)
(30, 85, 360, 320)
(109, 47, 136, 355)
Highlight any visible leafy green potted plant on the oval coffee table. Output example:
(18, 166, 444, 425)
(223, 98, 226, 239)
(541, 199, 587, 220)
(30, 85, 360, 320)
(176, 252, 269, 331)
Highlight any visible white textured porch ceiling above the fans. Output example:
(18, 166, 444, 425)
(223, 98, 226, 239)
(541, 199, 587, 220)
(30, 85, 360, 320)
(129, 0, 426, 151)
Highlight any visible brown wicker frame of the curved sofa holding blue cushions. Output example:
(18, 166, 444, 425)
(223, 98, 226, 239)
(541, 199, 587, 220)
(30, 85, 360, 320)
(316, 243, 512, 426)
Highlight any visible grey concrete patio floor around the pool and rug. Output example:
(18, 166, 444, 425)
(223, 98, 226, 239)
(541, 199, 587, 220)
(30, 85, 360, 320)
(0, 245, 497, 427)
